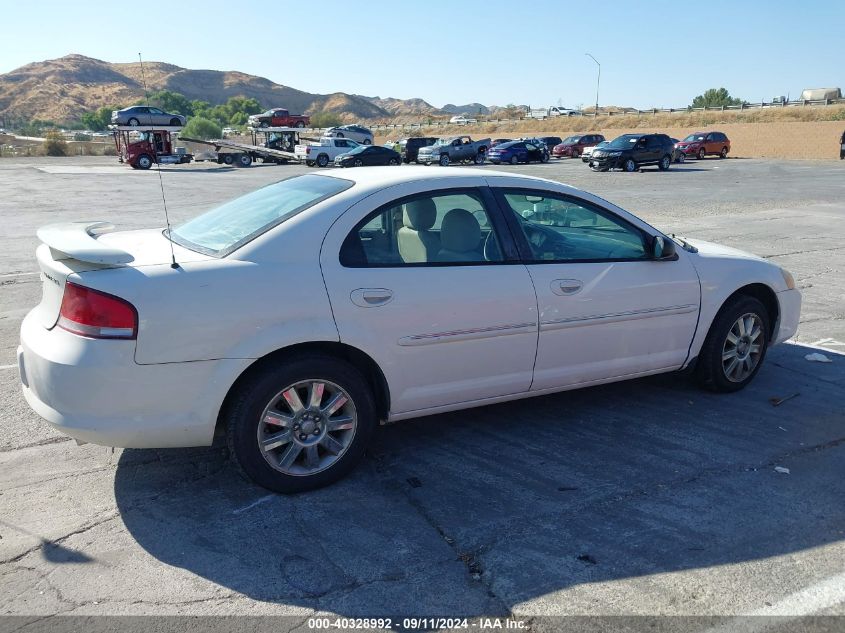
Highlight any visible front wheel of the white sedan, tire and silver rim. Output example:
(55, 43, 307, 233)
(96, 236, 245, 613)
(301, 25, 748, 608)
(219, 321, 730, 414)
(696, 295, 771, 393)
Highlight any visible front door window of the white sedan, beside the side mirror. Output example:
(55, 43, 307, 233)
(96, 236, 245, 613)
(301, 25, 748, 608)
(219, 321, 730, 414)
(502, 190, 649, 263)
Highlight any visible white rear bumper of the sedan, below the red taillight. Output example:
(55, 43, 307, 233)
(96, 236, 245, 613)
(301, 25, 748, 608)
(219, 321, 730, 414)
(18, 312, 244, 448)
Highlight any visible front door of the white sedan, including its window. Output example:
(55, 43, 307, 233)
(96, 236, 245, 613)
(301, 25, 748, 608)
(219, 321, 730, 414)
(499, 190, 700, 390)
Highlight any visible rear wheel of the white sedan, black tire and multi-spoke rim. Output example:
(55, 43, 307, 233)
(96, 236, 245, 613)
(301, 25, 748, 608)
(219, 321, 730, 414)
(224, 355, 377, 494)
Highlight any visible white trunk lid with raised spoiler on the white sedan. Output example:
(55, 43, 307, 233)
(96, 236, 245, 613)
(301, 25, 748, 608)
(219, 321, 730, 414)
(35, 222, 213, 329)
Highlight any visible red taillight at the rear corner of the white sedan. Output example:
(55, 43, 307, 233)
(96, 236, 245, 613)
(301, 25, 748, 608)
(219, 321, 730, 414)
(58, 282, 138, 339)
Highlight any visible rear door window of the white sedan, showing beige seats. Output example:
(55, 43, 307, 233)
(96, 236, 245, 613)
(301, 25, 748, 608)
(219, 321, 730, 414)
(340, 191, 503, 268)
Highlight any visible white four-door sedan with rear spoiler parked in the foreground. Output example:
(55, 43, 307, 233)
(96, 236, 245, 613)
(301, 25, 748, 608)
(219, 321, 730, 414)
(18, 167, 801, 492)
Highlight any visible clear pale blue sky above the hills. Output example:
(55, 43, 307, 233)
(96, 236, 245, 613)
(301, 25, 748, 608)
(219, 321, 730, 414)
(0, 0, 845, 108)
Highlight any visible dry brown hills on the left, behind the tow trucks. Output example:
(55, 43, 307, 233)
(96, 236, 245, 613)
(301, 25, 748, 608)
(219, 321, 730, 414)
(0, 55, 454, 122)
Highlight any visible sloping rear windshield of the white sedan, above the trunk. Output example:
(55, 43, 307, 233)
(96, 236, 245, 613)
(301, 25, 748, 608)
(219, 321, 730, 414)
(171, 175, 353, 257)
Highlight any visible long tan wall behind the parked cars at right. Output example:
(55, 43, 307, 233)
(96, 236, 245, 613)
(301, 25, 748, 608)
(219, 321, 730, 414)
(375, 118, 845, 159)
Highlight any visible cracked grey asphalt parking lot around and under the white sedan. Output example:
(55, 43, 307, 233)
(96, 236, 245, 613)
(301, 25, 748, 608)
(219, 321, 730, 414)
(0, 158, 845, 629)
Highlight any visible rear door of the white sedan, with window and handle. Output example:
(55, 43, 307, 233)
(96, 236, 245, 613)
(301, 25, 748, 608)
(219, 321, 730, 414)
(320, 183, 537, 414)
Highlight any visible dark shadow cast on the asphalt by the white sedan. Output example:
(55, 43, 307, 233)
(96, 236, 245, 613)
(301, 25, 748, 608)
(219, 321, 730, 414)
(114, 345, 845, 616)
